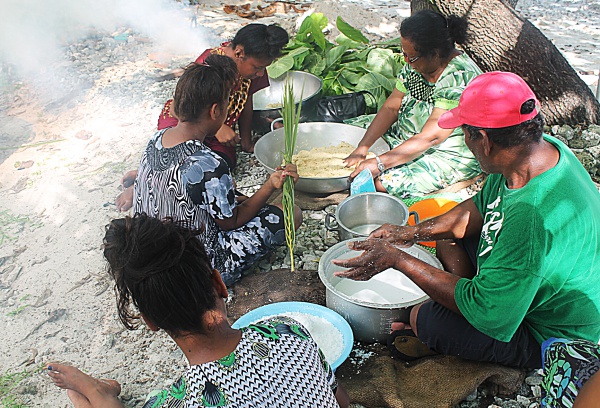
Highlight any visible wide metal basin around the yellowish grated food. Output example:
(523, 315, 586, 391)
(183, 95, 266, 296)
(254, 122, 390, 194)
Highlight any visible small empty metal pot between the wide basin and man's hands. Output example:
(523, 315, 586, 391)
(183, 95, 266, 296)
(325, 193, 409, 240)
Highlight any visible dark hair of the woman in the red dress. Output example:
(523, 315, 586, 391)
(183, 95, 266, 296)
(231, 23, 289, 60)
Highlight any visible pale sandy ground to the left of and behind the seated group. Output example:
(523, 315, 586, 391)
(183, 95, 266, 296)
(0, 0, 600, 407)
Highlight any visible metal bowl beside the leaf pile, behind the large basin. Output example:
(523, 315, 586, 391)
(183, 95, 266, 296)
(252, 71, 323, 135)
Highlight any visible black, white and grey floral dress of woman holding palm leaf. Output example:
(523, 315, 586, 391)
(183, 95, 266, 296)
(133, 129, 285, 286)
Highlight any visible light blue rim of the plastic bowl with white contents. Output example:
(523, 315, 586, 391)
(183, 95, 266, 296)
(232, 302, 354, 371)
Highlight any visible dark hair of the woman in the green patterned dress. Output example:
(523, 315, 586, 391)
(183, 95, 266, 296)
(400, 10, 467, 58)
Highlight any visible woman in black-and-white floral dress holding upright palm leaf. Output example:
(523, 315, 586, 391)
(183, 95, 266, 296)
(125, 54, 302, 286)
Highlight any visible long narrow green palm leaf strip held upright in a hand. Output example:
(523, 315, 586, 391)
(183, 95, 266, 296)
(281, 81, 302, 271)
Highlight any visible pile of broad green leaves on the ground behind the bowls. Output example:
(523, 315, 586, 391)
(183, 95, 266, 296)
(267, 13, 404, 111)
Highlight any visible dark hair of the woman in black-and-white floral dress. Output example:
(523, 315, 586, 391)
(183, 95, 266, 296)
(172, 54, 237, 122)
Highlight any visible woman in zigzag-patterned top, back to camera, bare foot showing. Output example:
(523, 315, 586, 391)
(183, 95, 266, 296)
(48, 214, 348, 408)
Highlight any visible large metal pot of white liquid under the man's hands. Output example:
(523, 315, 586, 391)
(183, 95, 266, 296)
(319, 238, 443, 343)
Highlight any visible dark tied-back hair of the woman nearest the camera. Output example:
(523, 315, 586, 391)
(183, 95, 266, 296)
(103, 214, 217, 335)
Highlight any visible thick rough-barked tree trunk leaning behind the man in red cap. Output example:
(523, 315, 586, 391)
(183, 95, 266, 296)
(411, 0, 600, 126)
